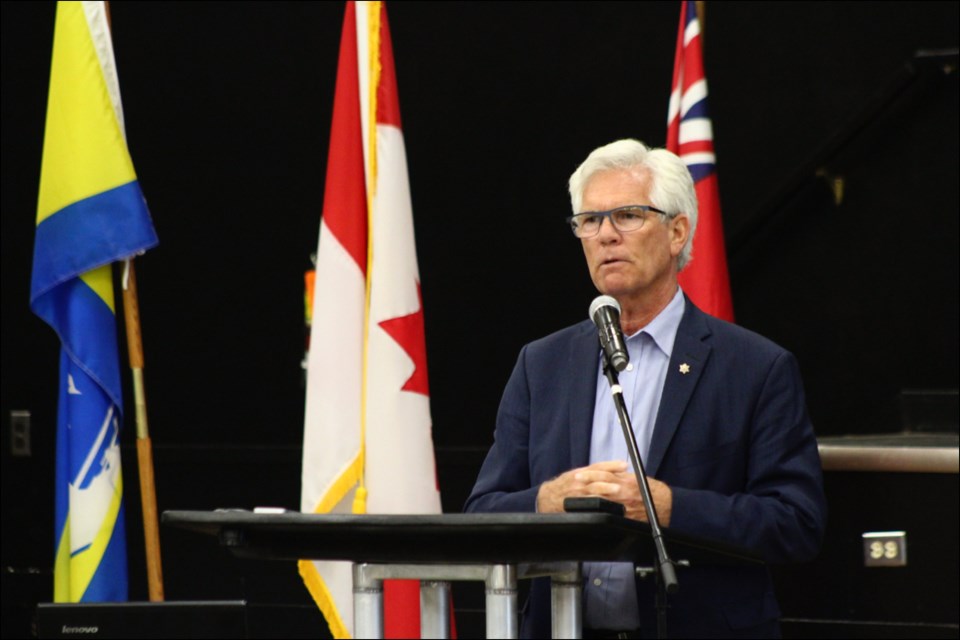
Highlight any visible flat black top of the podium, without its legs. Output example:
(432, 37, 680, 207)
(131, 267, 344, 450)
(162, 509, 760, 564)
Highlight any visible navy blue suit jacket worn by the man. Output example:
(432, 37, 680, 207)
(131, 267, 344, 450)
(465, 299, 826, 638)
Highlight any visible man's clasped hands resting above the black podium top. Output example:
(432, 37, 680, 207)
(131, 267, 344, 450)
(537, 460, 673, 527)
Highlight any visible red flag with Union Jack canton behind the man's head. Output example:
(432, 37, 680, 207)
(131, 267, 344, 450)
(667, 2, 733, 322)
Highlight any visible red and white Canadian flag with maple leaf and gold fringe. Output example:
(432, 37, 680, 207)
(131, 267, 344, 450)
(300, 2, 440, 638)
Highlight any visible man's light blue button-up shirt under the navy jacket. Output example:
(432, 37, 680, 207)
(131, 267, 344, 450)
(583, 287, 685, 629)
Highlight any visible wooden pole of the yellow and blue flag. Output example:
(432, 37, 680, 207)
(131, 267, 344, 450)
(123, 259, 163, 602)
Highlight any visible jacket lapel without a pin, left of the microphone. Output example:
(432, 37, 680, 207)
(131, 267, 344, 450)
(568, 321, 600, 468)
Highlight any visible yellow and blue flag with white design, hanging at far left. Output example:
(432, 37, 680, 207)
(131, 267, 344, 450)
(30, 2, 157, 602)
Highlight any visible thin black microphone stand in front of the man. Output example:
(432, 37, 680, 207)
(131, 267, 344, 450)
(603, 358, 680, 638)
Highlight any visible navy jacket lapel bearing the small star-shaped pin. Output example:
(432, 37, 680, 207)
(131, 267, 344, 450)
(644, 298, 712, 477)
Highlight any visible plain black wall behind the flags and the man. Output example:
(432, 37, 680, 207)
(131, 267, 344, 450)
(0, 2, 958, 636)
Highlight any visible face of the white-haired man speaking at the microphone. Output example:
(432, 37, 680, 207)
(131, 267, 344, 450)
(577, 170, 687, 300)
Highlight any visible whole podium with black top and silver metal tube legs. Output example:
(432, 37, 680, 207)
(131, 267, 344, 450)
(162, 510, 759, 638)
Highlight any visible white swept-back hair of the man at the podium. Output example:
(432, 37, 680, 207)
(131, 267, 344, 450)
(570, 139, 697, 269)
